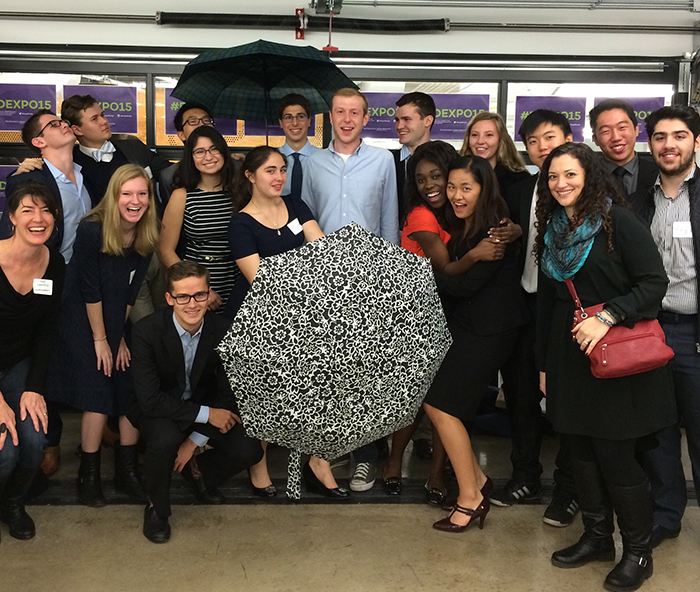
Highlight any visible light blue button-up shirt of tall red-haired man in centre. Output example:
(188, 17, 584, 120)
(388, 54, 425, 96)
(301, 141, 399, 244)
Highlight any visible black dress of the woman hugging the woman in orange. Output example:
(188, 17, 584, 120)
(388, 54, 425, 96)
(425, 232, 527, 421)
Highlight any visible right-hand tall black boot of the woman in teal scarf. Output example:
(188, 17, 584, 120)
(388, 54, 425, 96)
(605, 480, 654, 592)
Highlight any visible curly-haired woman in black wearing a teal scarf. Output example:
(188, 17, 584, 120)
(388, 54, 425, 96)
(535, 144, 676, 591)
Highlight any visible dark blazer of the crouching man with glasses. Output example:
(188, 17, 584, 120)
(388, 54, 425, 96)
(127, 307, 236, 430)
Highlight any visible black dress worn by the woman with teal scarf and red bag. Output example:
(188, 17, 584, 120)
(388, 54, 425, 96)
(537, 206, 676, 440)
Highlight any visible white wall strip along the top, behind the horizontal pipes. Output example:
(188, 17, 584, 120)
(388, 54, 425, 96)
(0, 0, 699, 57)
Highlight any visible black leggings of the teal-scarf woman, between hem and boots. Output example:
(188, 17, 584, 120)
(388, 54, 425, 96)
(567, 435, 647, 487)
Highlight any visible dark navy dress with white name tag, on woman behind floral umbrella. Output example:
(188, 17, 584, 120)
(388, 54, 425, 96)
(224, 195, 314, 319)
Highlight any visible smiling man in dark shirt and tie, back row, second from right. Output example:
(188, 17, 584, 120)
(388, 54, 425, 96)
(588, 99, 659, 196)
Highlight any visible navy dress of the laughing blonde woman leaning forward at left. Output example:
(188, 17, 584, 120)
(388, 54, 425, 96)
(48, 220, 151, 415)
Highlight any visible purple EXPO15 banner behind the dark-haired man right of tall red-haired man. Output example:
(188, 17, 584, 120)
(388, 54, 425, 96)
(362, 93, 490, 140)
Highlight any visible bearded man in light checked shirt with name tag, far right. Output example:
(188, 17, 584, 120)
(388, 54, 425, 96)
(630, 106, 700, 548)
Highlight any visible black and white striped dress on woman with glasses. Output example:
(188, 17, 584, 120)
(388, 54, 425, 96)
(183, 189, 241, 310)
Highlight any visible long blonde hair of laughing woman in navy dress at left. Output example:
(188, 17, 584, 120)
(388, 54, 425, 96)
(85, 164, 158, 257)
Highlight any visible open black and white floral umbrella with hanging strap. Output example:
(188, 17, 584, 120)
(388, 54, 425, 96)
(218, 223, 452, 499)
